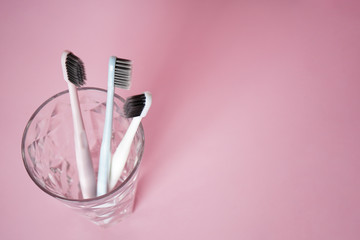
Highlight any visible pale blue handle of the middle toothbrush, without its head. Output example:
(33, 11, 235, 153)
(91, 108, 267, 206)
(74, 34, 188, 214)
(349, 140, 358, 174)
(96, 79, 115, 196)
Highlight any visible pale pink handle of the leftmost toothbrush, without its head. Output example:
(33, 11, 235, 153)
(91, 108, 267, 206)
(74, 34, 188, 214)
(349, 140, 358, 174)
(68, 83, 96, 198)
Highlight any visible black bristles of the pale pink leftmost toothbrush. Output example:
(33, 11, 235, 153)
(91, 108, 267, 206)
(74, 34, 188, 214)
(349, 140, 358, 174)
(66, 53, 86, 87)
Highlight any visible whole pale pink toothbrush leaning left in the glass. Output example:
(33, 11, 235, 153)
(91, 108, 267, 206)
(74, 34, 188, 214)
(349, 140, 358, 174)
(61, 51, 96, 198)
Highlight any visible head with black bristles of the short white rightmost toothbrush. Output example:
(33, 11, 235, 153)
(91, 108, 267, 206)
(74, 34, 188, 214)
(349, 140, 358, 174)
(124, 92, 152, 118)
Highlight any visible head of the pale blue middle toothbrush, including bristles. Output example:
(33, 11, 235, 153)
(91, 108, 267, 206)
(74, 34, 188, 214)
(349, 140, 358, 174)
(109, 56, 131, 89)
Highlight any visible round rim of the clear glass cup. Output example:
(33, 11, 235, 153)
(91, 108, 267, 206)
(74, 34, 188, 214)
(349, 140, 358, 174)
(21, 87, 145, 202)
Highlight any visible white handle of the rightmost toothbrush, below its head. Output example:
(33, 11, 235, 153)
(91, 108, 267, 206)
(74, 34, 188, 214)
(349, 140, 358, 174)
(109, 116, 142, 190)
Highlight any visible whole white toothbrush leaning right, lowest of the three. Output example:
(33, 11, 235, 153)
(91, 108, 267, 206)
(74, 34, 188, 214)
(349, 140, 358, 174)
(109, 92, 152, 189)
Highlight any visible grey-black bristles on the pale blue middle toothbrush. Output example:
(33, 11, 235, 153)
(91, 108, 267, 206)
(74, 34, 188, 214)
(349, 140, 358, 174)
(114, 58, 131, 89)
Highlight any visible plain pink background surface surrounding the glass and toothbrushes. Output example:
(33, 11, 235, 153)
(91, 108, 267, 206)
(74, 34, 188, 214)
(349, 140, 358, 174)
(0, 0, 360, 240)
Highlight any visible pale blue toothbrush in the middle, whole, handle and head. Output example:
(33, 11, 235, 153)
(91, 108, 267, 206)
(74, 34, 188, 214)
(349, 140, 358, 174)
(96, 56, 131, 196)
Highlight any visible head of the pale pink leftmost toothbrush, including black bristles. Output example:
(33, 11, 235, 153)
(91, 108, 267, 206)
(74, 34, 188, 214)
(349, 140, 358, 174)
(61, 51, 86, 87)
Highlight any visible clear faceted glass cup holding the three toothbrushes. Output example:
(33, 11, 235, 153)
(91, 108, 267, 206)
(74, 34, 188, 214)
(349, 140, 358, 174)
(21, 87, 145, 226)
